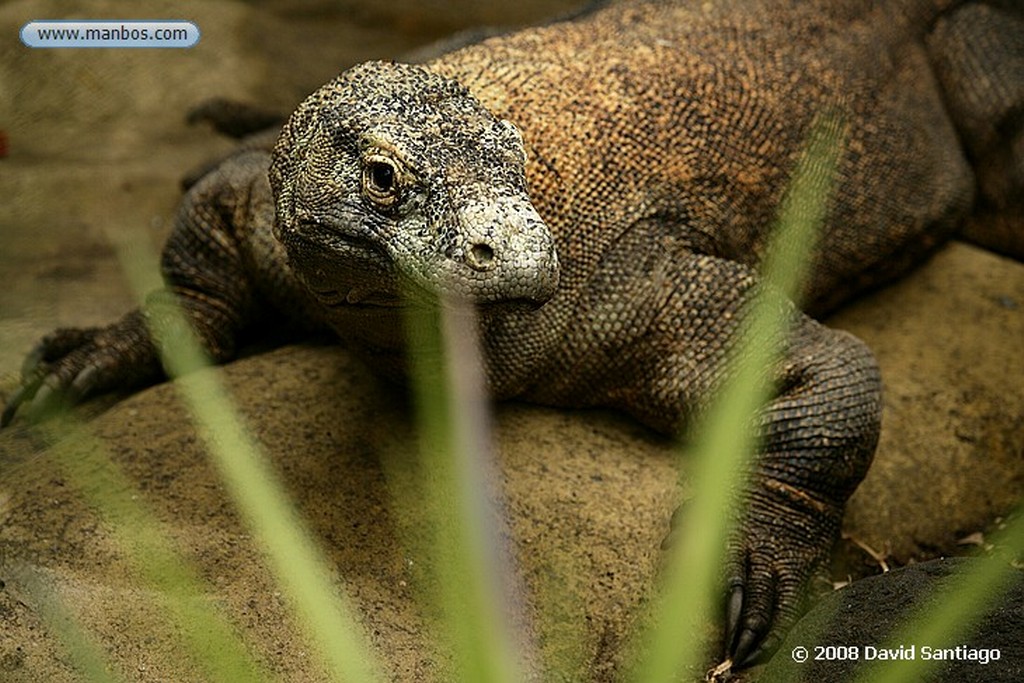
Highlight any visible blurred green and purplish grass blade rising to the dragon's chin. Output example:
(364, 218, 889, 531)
(409, 305, 522, 683)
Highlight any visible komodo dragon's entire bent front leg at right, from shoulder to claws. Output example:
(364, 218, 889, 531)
(537, 240, 881, 667)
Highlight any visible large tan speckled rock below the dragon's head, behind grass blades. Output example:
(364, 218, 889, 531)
(0, 346, 678, 683)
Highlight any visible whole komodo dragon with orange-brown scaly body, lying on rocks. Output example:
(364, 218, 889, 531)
(4, 0, 1024, 666)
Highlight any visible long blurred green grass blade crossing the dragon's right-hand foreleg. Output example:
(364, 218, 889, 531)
(628, 116, 845, 683)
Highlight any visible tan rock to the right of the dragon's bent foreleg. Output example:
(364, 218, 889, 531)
(828, 243, 1024, 571)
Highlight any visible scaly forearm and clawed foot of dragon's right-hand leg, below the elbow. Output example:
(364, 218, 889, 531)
(726, 321, 881, 667)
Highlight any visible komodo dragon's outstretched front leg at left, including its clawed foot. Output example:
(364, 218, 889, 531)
(0, 153, 269, 426)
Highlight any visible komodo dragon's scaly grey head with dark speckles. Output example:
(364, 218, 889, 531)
(270, 62, 558, 313)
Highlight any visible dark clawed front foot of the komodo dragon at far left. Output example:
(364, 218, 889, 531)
(0, 310, 161, 428)
